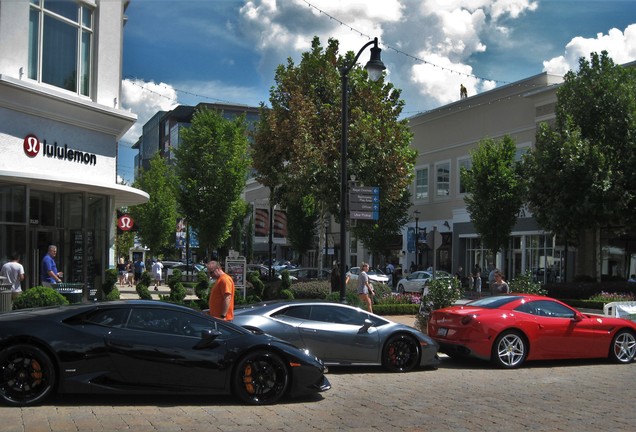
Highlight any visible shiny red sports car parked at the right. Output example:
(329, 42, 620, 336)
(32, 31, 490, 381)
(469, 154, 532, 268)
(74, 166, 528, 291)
(428, 294, 636, 368)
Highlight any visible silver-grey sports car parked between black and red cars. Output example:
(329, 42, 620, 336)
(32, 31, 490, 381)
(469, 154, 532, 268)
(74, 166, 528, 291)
(234, 301, 439, 372)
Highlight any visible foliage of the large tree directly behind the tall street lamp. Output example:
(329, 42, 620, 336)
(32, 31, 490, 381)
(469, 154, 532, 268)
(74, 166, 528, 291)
(252, 38, 416, 251)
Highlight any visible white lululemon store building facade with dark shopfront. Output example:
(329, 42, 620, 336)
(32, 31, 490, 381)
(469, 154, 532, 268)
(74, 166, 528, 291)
(0, 0, 149, 288)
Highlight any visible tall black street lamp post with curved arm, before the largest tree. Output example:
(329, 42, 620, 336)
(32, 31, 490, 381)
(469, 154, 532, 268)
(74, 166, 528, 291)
(340, 38, 386, 302)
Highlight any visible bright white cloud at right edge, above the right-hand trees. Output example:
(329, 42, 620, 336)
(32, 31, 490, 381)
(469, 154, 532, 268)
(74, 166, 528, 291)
(543, 24, 636, 75)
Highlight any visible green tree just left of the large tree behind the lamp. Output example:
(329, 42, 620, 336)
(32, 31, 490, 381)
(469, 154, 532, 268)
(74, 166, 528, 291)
(174, 108, 250, 250)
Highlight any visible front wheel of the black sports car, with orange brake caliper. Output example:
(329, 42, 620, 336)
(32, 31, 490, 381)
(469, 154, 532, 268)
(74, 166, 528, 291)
(234, 351, 289, 405)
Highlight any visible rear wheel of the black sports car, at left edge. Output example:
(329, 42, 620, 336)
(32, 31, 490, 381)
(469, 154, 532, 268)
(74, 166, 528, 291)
(0, 345, 56, 406)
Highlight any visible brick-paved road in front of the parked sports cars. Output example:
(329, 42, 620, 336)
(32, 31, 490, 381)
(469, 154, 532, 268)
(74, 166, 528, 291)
(0, 357, 636, 432)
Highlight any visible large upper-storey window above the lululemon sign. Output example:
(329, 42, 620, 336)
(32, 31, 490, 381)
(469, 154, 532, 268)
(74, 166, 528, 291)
(28, 0, 93, 96)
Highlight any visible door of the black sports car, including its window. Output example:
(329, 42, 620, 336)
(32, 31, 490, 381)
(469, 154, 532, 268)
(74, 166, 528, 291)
(105, 307, 229, 389)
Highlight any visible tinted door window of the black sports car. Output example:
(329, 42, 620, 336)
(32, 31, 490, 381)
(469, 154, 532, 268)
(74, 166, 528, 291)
(127, 308, 221, 337)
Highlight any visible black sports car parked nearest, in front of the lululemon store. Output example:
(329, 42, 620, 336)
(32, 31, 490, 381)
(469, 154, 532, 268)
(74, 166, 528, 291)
(0, 300, 331, 405)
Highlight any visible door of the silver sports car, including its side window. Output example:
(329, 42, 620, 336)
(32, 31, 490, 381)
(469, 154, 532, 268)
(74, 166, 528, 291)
(299, 305, 379, 363)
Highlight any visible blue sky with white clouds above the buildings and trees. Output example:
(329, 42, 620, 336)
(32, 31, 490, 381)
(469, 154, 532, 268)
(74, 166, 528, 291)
(118, 0, 636, 183)
